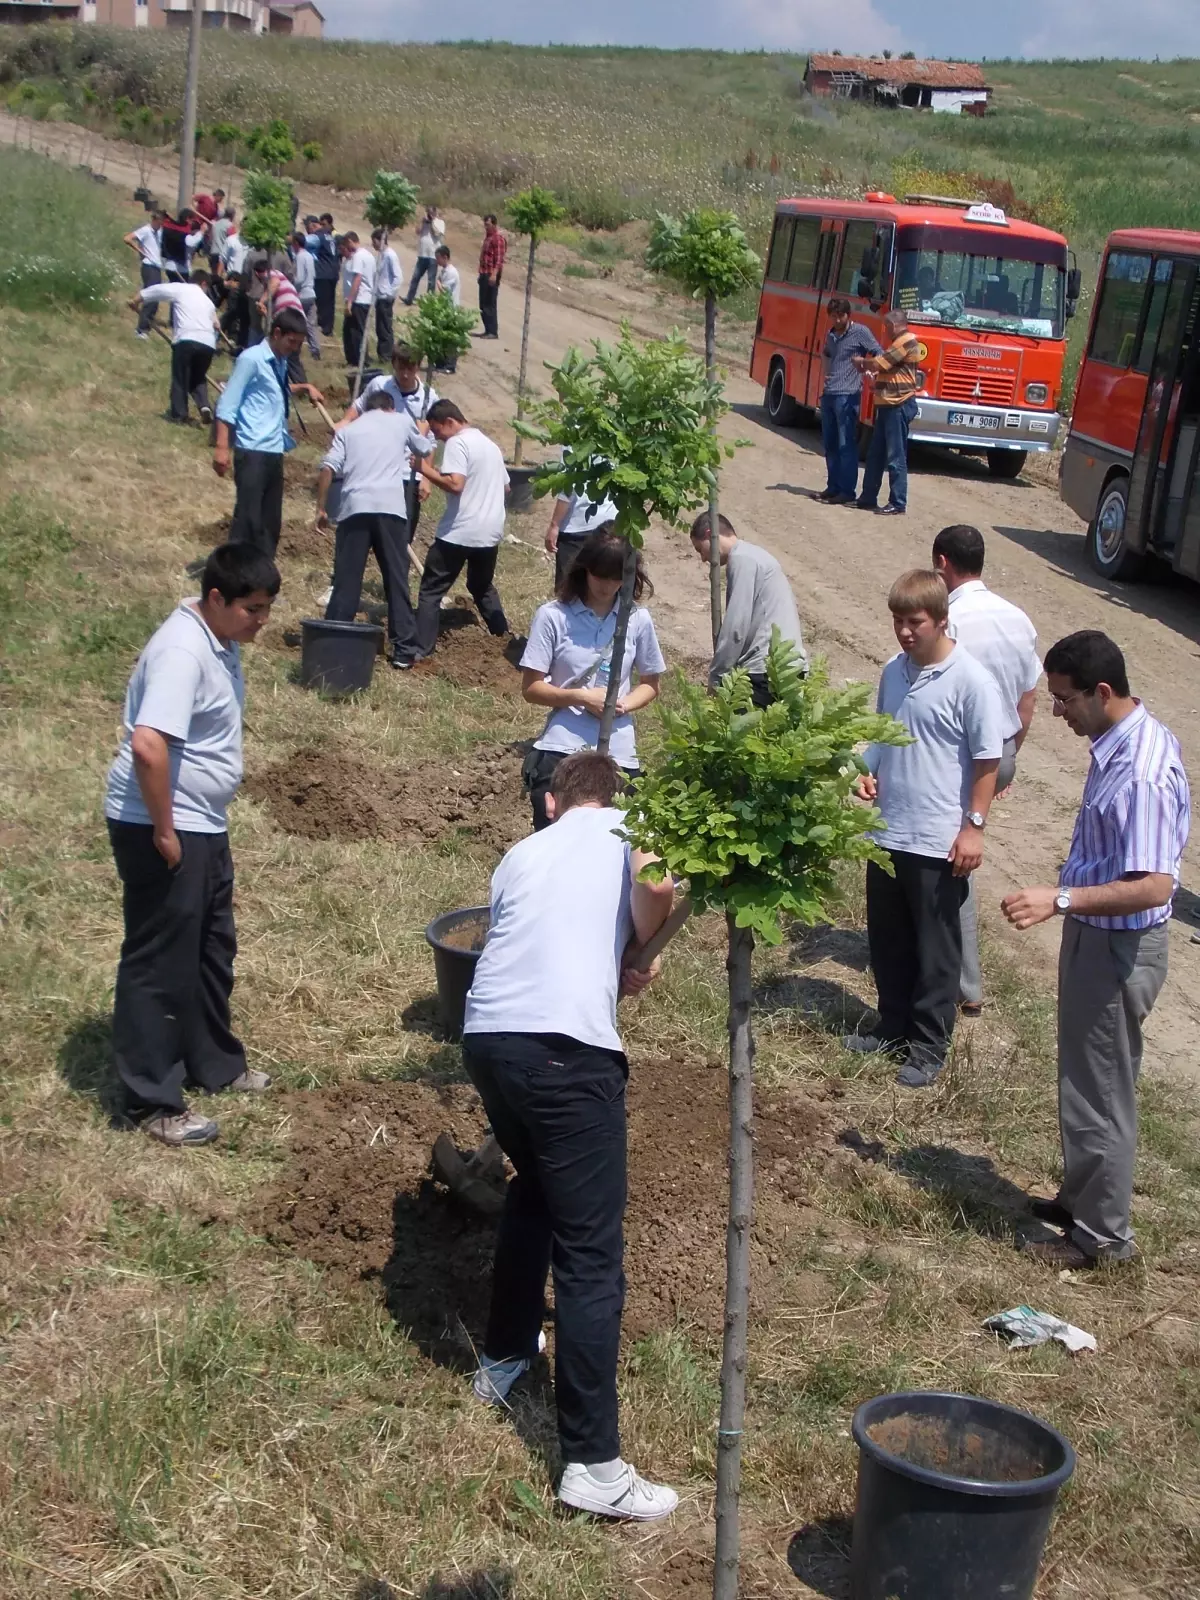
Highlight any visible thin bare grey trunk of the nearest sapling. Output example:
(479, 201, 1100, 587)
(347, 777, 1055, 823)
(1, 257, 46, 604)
(712, 912, 754, 1600)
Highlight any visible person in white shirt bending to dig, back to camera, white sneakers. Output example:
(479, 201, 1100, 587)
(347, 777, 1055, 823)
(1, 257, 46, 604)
(462, 750, 678, 1522)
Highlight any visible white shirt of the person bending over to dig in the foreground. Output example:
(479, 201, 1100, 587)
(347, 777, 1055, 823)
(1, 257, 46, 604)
(462, 806, 634, 1050)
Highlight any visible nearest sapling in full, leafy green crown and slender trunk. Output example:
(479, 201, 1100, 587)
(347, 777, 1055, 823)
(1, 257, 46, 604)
(624, 629, 909, 1600)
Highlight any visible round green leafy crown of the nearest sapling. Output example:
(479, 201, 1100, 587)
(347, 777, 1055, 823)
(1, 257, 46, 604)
(626, 629, 909, 944)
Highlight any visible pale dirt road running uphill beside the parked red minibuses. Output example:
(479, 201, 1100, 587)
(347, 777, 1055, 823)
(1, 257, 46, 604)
(16, 115, 1200, 1083)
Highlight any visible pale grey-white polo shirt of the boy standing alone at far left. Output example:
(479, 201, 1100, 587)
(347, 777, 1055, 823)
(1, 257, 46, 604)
(104, 600, 246, 834)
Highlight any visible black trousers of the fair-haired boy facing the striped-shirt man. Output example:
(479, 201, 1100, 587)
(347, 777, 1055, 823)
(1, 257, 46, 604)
(867, 850, 966, 1067)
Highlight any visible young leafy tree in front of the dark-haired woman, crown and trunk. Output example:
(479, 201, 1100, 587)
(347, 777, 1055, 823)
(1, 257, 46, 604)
(518, 323, 733, 755)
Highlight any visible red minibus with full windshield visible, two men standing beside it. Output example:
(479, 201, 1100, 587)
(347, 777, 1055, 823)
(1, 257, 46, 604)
(750, 194, 1078, 478)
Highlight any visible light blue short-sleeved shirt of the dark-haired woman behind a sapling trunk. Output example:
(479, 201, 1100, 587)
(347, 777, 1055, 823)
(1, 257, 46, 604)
(522, 600, 667, 768)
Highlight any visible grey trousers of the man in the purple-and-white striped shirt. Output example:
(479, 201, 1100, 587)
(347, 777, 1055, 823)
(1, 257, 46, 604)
(1058, 917, 1168, 1259)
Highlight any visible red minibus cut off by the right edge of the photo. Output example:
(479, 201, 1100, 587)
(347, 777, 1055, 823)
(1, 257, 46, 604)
(1059, 227, 1200, 579)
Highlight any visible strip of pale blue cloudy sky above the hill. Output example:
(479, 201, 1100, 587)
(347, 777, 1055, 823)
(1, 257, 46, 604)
(318, 0, 1200, 59)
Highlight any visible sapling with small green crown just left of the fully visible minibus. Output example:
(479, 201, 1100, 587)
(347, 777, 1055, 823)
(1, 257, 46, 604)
(646, 210, 762, 646)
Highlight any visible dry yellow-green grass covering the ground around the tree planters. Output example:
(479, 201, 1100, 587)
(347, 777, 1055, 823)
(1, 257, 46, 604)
(0, 152, 1200, 1600)
